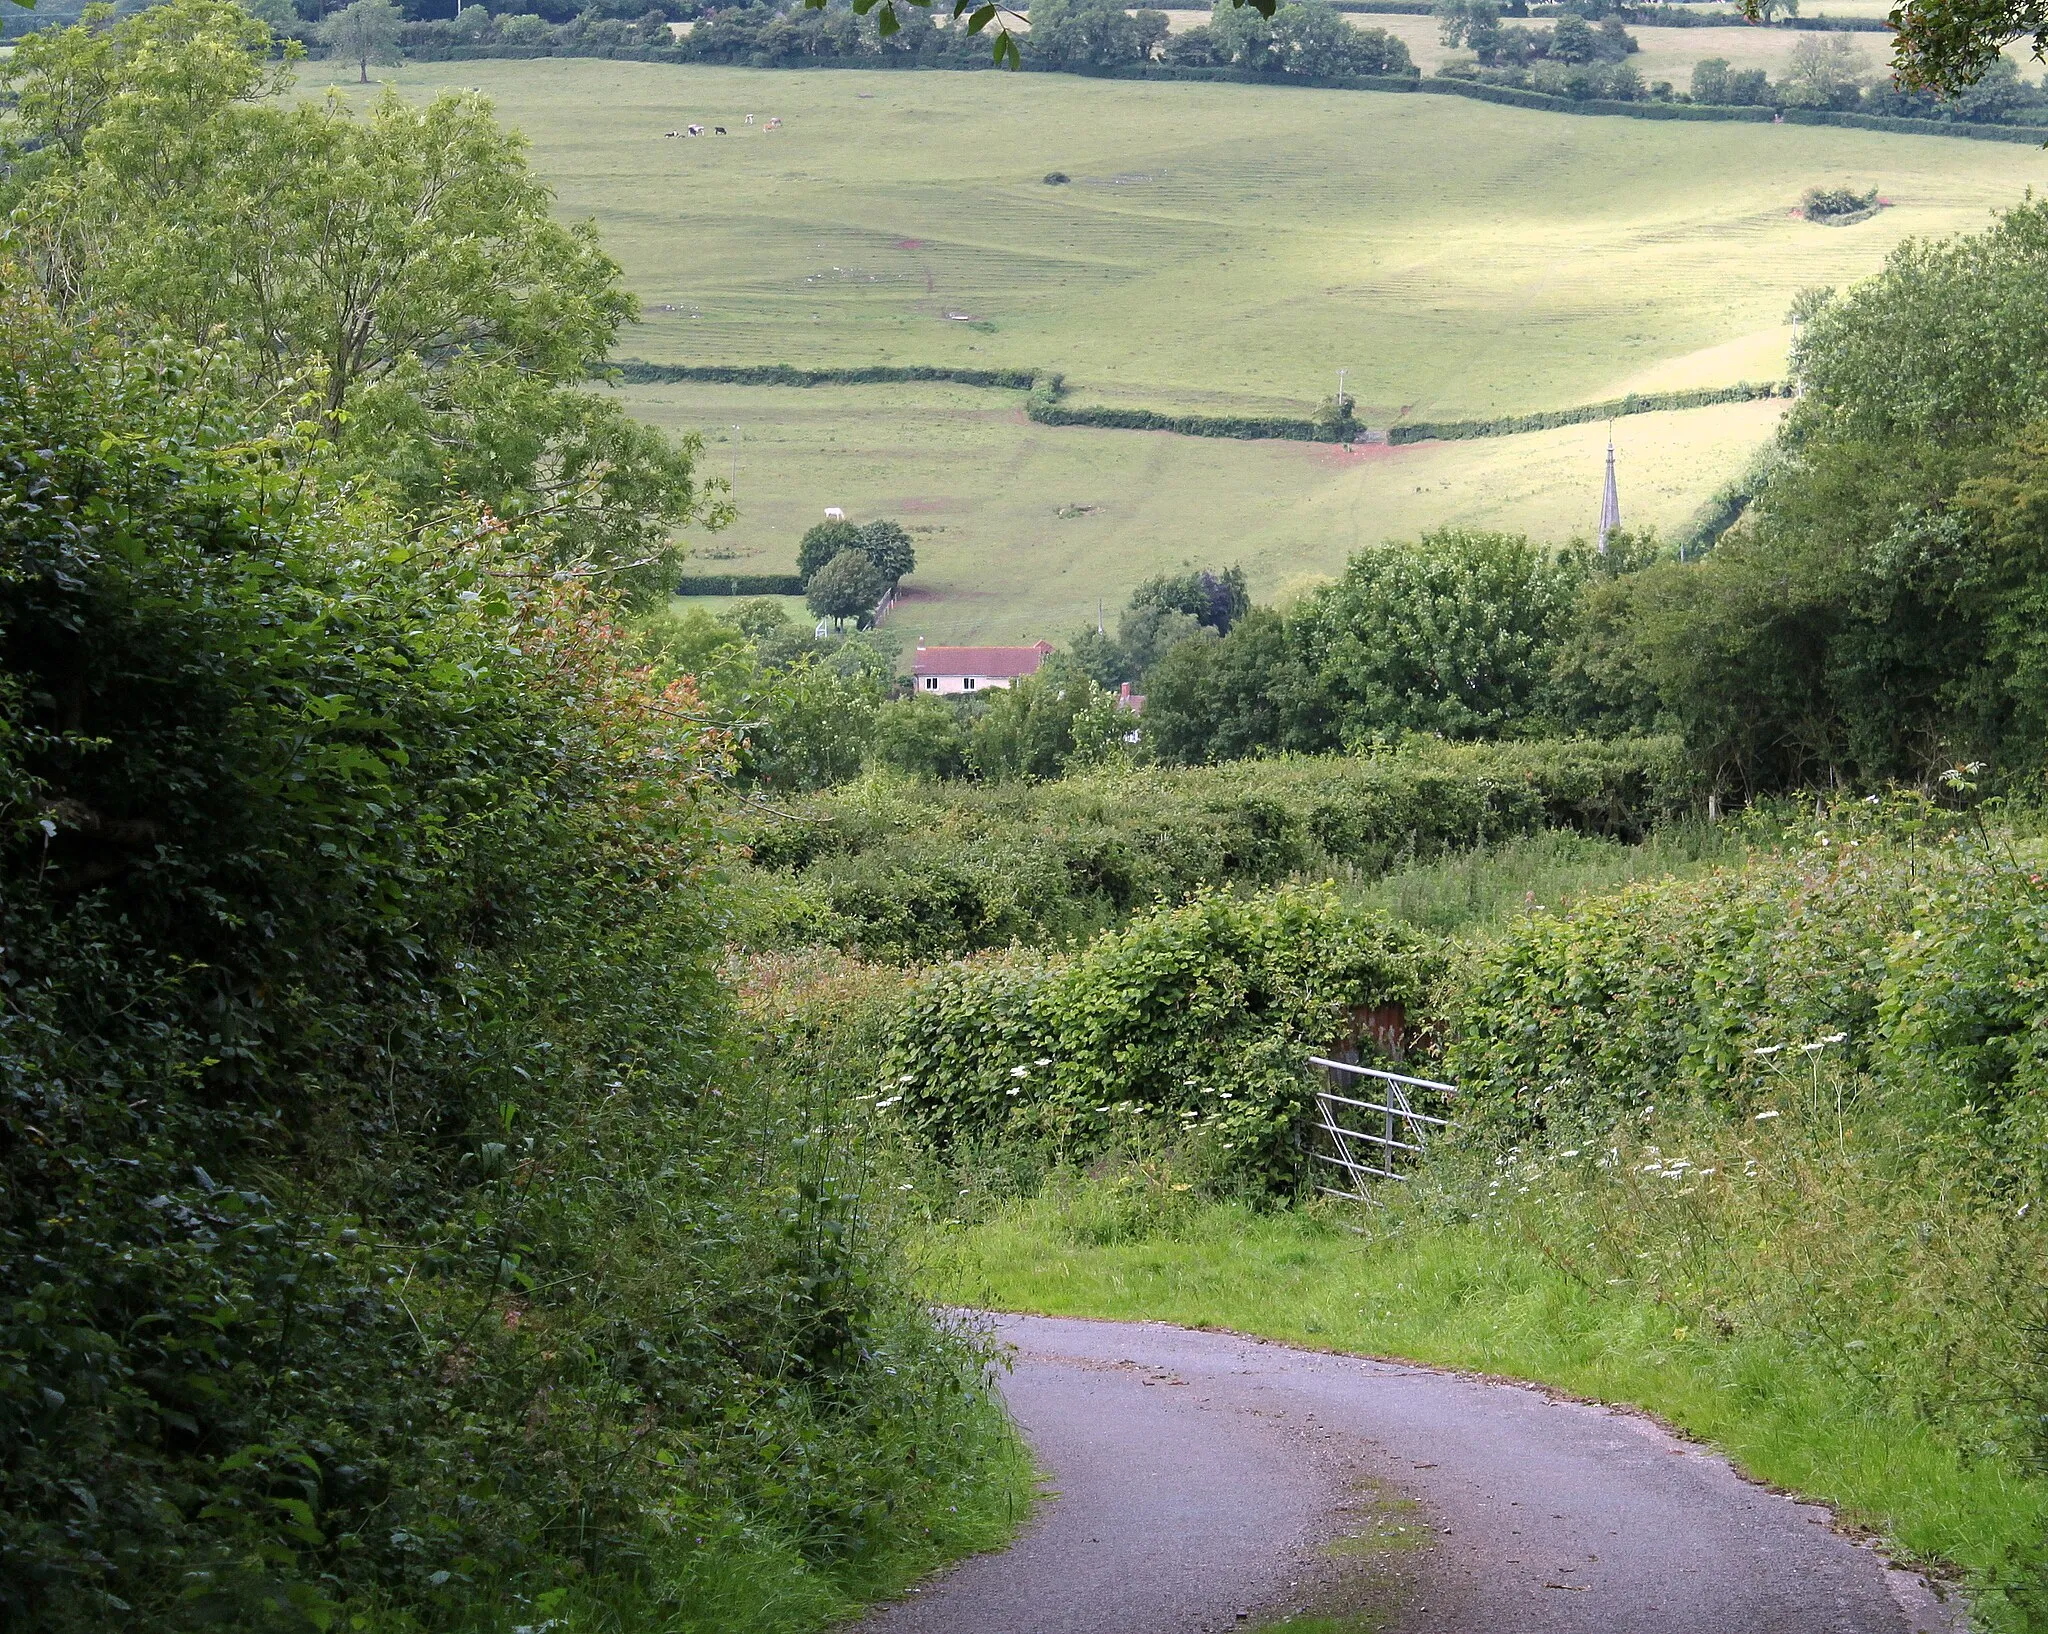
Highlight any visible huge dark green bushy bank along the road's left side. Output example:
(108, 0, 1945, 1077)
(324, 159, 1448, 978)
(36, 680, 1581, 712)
(0, 295, 1019, 1634)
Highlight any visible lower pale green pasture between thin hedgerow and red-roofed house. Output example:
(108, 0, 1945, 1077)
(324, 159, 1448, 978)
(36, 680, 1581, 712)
(621, 383, 1784, 641)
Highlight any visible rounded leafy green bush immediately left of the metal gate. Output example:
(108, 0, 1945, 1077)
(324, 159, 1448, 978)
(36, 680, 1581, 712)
(881, 889, 1440, 1188)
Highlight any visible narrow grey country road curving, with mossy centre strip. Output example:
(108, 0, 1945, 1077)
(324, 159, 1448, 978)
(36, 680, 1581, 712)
(860, 1317, 1960, 1634)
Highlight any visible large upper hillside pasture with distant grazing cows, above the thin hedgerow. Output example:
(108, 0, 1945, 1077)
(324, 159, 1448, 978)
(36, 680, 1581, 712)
(307, 61, 2048, 424)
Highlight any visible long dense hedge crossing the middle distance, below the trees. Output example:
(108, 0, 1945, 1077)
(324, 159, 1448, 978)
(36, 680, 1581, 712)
(752, 739, 1694, 958)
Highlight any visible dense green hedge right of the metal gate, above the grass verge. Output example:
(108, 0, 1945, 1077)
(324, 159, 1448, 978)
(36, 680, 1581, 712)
(1448, 805, 2048, 1200)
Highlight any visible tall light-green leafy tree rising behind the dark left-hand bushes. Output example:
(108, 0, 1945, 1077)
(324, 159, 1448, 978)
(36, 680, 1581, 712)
(6, 0, 723, 600)
